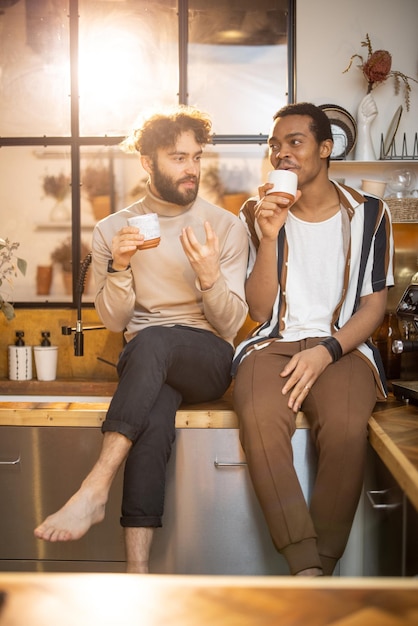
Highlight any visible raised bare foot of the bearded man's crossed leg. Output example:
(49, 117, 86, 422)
(34, 486, 106, 542)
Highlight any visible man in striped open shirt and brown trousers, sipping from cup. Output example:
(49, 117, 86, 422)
(233, 103, 393, 576)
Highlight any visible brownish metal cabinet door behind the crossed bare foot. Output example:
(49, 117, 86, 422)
(0, 426, 125, 569)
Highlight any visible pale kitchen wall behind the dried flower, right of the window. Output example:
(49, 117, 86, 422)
(296, 0, 418, 154)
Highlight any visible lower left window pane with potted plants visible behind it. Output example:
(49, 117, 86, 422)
(0, 147, 72, 302)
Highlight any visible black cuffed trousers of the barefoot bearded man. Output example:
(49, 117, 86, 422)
(102, 326, 233, 527)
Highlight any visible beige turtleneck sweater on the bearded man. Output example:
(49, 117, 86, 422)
(92, 189, 248, 344)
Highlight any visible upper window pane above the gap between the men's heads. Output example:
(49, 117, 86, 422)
(188, 0, 288, 135)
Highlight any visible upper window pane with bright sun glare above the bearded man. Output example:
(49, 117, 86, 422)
(79, 0, 179, 136)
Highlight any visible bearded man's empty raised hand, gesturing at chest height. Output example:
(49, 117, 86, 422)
(180, 222, 221, 290)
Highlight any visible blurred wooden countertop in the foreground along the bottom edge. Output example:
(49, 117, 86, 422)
(0, 573, 418, 626)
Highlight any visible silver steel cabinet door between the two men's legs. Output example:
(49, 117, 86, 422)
(151, 429, 314, 575)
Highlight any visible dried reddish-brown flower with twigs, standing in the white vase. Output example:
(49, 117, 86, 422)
(343, 33, 418, 111)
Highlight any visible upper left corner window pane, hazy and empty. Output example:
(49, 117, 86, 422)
(0, 0, 70, 137)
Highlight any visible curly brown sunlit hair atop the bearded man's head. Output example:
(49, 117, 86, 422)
(122, 106, 212, 158)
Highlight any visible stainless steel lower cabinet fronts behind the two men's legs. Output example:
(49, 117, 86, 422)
(0, 426, 315, 575)
